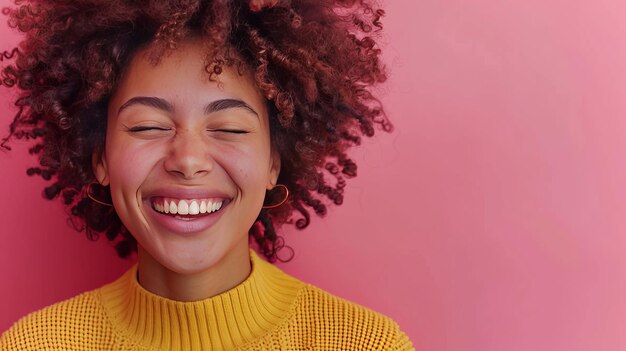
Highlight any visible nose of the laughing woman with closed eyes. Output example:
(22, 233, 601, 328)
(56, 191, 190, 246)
(164, 131, 214, 180)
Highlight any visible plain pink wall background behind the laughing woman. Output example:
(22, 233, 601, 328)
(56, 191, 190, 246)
(0, 0, 626, 351)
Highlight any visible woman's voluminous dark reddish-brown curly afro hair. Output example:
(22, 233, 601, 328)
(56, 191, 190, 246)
(0, 0, 392, 261)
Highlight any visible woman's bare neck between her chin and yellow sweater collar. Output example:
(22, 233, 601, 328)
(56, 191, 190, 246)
(138, 245, 251, 302)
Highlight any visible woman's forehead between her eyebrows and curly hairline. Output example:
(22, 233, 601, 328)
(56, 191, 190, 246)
(109, 39, 265, 115)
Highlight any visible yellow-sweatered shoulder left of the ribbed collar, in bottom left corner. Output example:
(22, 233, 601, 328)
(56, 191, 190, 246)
(0, 290, 111, 351)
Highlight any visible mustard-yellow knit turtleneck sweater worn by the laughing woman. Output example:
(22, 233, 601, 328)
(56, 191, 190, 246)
(0, 253, 413, 351)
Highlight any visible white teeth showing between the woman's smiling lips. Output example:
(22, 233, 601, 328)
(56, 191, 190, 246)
(152, 197, 226, 220)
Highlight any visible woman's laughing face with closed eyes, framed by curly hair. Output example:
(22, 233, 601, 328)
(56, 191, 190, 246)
(94, 40, 280, 274)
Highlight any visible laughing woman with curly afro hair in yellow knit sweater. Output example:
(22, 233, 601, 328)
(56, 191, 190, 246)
(0, 0, 412, 350)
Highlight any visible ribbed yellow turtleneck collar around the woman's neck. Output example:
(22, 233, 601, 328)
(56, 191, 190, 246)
(100, 251, 302, 350)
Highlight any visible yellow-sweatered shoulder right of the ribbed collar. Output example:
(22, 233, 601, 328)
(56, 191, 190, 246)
(288, 284, 413, 350)
